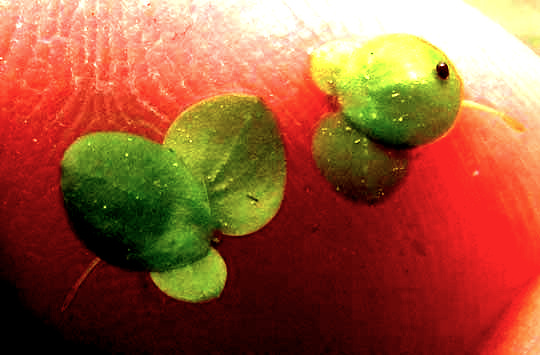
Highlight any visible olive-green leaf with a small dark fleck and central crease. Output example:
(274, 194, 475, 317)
(164, 94, 286, 235)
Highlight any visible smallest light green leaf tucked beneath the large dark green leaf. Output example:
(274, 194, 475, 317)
(150, 248, 227, 302)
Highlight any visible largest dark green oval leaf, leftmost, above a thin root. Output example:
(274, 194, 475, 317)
(61, 132, 215, 271)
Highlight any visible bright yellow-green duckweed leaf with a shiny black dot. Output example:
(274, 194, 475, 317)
(335, 34, 462, 147)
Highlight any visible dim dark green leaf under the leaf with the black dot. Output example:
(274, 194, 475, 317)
(313, 113, 407, 203)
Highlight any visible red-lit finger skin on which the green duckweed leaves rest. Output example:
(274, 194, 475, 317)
(0, 0, 540, 354)
